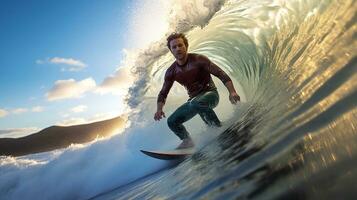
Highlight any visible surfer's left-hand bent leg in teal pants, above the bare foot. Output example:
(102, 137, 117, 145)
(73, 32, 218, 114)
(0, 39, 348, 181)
(167, 102, 197, 140)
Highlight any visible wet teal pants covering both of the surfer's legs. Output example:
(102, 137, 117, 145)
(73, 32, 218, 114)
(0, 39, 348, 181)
(167, 90, 221, 140)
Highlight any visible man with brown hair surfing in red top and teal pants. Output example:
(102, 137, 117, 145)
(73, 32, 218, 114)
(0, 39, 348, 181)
(154, 33, 240, 149)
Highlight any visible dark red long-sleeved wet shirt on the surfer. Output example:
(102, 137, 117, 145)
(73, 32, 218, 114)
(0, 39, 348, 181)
(157, 53, 231, 103)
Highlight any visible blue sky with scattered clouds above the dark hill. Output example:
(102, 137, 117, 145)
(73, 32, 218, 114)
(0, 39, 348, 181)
(0, 0, 157, 137)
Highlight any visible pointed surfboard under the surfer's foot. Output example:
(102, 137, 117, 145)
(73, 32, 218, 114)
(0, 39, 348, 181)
(140, 148, 194, 160)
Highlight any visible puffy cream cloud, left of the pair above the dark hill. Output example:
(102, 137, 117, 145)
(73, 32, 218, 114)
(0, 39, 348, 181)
(45, 77, 96, 101)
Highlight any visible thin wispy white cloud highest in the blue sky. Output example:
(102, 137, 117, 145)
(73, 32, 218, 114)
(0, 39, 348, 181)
(36, 57, 87, 71)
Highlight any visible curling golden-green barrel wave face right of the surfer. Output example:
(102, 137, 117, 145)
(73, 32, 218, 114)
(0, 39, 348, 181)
(113, 1, 357, 199)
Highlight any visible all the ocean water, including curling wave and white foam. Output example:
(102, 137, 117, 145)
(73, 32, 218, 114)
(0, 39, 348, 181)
(0, 0, 357, 199)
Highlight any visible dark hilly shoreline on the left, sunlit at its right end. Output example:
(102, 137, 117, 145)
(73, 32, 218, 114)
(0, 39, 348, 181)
(0, 117, 125, 156)
